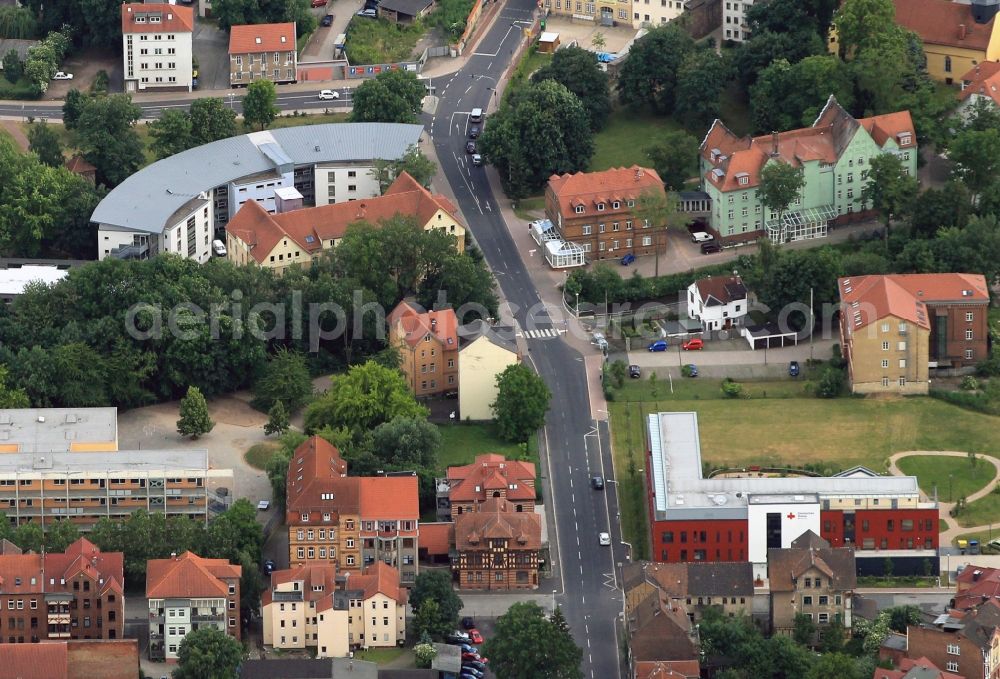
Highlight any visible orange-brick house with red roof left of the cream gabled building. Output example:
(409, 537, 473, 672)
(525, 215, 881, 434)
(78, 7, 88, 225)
(386, 300, 459, 398)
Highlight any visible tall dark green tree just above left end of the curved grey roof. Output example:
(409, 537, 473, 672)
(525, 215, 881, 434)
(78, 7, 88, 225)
(76, 94, 145, 186)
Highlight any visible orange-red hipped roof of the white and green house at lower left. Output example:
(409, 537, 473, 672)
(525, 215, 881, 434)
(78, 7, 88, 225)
(146, 552, 243, 599)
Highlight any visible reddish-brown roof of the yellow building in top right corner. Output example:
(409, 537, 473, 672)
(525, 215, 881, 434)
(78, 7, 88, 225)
(893, 0, 995, 51)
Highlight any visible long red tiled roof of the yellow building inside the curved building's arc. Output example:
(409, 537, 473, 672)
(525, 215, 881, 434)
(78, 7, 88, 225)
(226, 172, 458, 263)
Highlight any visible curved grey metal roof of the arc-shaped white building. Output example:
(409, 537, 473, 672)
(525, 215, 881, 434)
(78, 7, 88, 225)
(90, 123, 423, 233)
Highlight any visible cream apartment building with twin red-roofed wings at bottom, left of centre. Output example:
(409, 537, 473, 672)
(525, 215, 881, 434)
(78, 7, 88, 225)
(262, 561, 407, 658)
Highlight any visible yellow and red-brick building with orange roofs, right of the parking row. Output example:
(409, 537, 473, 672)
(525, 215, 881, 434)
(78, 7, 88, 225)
(838, 273, 990, 394)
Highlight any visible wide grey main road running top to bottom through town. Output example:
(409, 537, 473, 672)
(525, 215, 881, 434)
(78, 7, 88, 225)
(426, 5, 625, 679)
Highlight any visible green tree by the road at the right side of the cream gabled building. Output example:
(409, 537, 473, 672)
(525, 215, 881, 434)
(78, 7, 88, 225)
(490, 363, 552, 443)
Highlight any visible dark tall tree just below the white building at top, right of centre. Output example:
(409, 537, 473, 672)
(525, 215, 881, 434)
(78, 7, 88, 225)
(618, 22, 695, 114)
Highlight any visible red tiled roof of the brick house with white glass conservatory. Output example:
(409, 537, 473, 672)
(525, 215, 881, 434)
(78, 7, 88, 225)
(549, 165, 665, 215)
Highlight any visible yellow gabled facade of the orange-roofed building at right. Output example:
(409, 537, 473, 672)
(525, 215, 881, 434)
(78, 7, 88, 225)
(844, 316, 930, 394)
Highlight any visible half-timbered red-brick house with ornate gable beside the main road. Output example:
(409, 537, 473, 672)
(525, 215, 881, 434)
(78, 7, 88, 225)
(454, 497, 542, 590)
